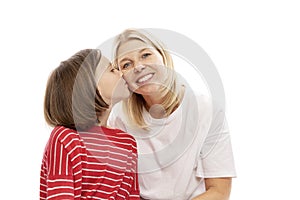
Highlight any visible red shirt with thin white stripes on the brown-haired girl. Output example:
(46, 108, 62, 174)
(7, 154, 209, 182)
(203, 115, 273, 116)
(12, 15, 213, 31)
(40, 126, 140, 200)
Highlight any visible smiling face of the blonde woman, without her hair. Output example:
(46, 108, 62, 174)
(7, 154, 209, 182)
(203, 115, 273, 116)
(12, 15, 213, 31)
(117, 39, 167, 95)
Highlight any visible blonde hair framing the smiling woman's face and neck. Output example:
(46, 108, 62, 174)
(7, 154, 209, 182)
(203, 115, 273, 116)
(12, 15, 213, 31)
(113, 29, 180, 129)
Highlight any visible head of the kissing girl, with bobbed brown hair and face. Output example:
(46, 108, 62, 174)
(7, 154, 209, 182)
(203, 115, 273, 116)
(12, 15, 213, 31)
(44, 49, 130, 130)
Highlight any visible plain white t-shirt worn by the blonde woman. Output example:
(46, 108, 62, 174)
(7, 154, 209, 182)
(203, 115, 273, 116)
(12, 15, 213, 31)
(108, 85, 236, 200)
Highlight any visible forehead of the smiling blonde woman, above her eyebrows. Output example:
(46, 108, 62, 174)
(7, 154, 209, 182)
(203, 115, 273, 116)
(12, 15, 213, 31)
(117, 39, 154, 57)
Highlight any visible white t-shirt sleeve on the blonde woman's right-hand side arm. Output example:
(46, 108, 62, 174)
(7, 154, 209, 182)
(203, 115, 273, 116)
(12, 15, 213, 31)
(196, 106, 236, 178)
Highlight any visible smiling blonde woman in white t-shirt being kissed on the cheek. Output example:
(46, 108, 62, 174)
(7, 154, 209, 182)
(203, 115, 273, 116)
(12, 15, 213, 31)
(108, 29, 235, 200)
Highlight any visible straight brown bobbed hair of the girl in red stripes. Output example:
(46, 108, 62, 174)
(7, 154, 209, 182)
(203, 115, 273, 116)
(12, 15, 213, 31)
(44, 49, 109, 130)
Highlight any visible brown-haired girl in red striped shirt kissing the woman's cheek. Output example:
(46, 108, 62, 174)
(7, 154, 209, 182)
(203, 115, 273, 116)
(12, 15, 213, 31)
(40, 49, 139, 200)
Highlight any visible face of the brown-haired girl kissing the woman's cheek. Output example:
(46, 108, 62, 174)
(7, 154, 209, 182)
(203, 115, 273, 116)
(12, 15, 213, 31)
(96, 57, 130, 104)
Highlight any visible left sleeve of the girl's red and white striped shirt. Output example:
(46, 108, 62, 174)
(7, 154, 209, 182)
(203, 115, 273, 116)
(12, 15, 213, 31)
(40, 127, 75, 200)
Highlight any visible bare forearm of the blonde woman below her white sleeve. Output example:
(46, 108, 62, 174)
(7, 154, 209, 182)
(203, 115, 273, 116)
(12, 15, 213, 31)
(193, 178, 231, 200)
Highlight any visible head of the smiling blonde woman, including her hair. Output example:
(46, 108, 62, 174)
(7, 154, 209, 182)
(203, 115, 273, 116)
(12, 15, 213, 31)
(113, 29, 179, 127)
